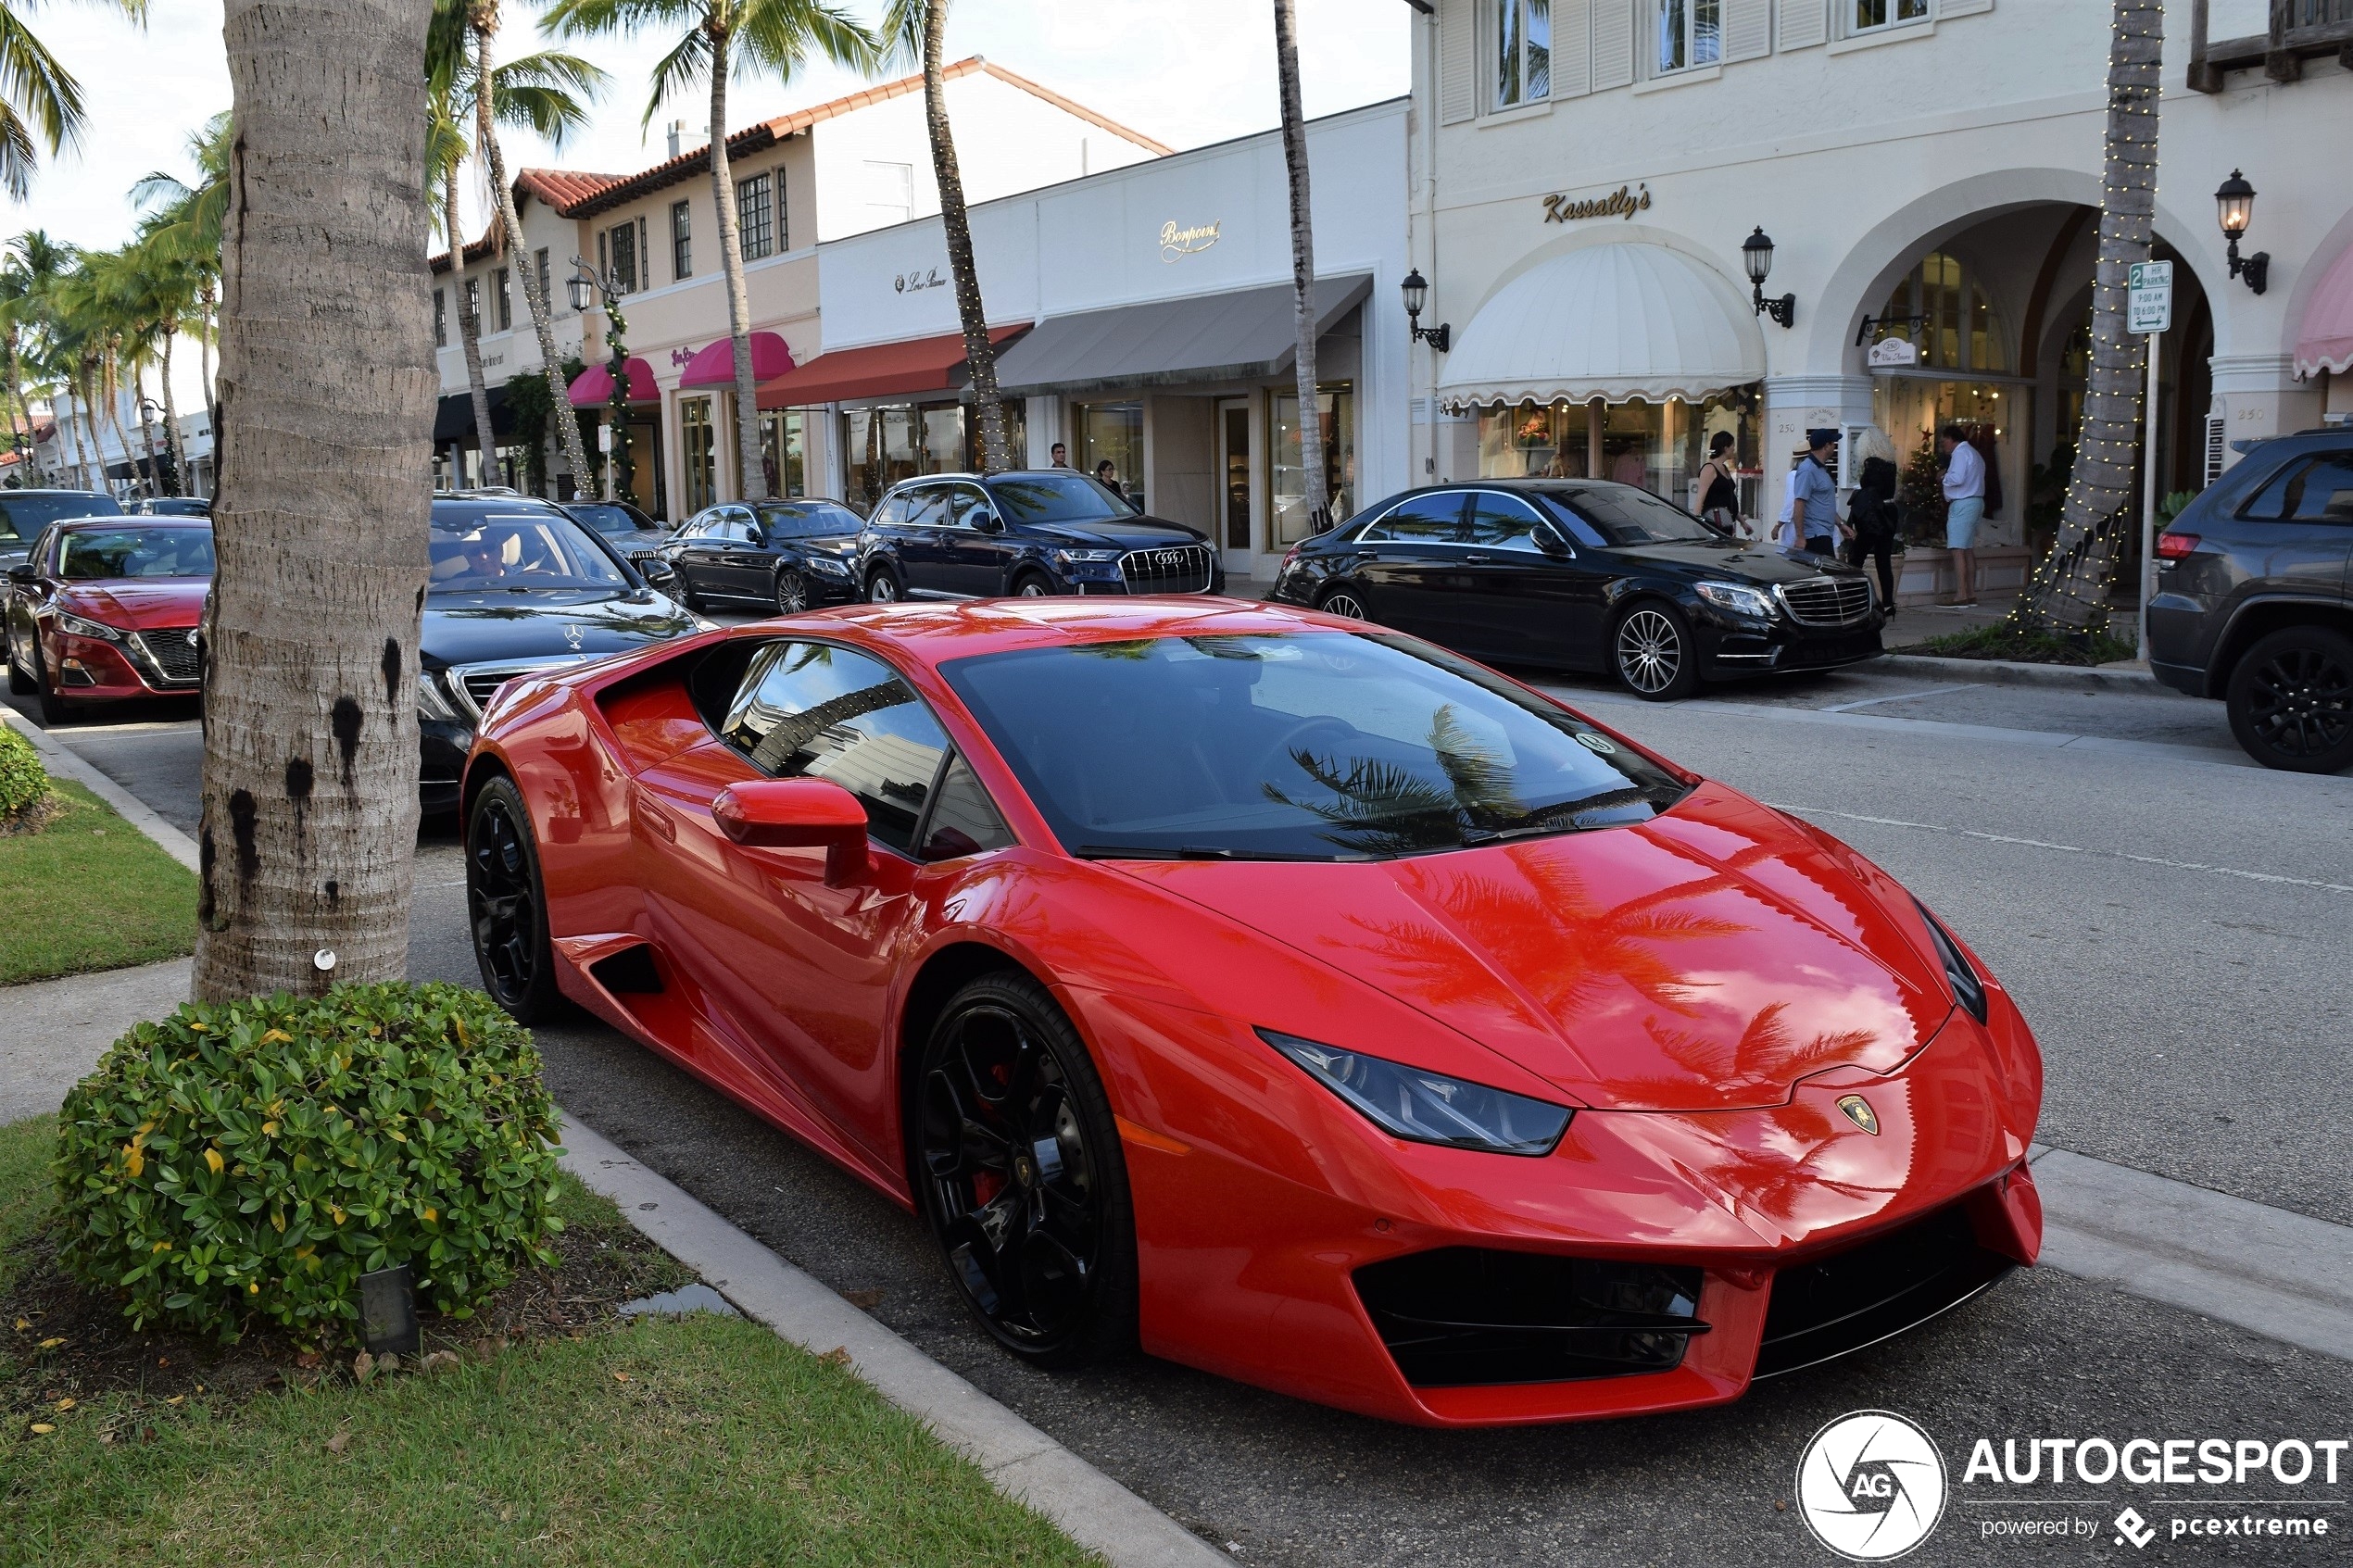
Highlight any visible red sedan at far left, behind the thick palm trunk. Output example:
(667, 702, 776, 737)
(7, 517, 212, 724)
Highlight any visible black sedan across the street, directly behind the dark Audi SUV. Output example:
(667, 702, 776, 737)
(661, 501, 866, 616)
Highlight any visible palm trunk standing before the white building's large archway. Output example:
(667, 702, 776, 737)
(2019, 0, 2165, 633)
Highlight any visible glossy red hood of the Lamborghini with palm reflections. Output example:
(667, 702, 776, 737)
(1123, 783, 1953, 1110)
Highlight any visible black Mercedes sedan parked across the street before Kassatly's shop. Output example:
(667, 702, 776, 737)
(1266, 480, 1887, 700)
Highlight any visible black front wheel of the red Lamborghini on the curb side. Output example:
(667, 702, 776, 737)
(913, 973, 1137, 1366)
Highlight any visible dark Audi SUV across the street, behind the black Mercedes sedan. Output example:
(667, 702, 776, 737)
(859, 468, 1226, 602)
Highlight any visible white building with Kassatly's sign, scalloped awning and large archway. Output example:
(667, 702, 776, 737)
(1412, 0, 2353, 597)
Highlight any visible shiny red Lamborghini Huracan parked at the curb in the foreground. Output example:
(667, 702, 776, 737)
(463, 599, 2043, 1424)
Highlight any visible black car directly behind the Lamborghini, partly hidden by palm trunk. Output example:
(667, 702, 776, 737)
(417, 496, 709, 813)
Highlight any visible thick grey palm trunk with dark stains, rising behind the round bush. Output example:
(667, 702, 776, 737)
(195, 0, 437, 1001)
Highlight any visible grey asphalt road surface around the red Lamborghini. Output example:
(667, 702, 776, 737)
(18, 672, 2353, 1565)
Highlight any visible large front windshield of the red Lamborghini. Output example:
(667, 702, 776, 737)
(941, 633, 1687, 860)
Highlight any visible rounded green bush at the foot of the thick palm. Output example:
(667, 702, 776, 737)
(54, 985, 562, 1342)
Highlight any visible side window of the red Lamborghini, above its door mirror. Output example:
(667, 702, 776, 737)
(720, 642, 969, 853)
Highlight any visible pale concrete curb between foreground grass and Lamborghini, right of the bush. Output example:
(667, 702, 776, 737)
(562, 1117, 1230, 1568)
